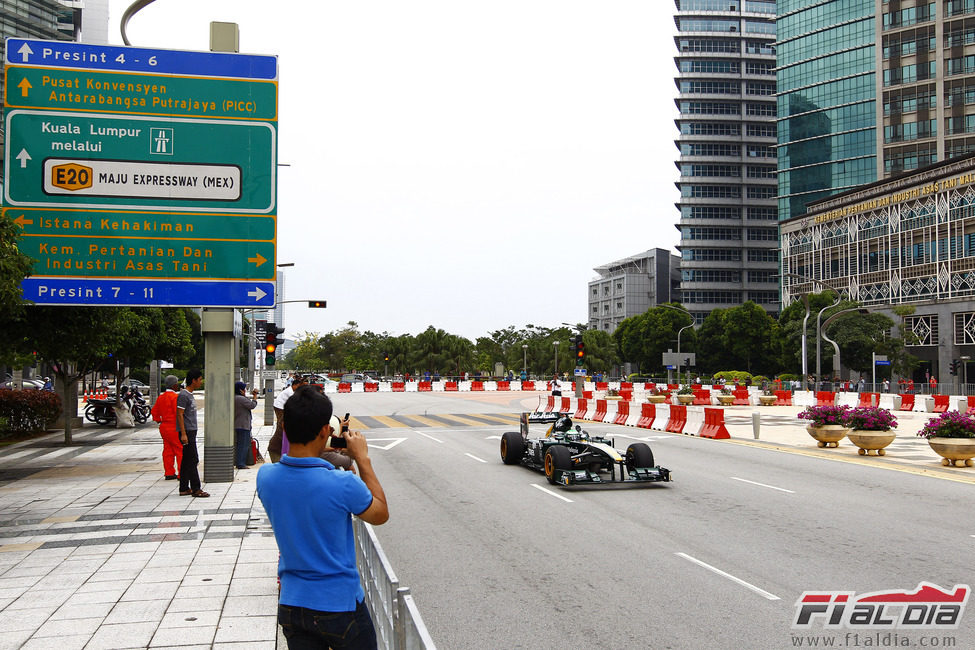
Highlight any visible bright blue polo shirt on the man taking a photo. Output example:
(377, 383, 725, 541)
(257, 455, 372, 612)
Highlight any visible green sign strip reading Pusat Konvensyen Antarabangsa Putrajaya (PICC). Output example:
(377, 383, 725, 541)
(4, 65, 277, 121)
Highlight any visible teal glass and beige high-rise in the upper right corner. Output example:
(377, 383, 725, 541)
(776, 0, 975, 220)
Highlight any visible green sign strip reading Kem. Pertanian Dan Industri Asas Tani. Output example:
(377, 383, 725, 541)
(18, 235, 275, 280)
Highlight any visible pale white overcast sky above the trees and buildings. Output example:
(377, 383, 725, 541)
(109, 0, 678, 340)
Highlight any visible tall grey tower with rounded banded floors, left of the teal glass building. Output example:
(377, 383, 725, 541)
(674, 0, 779, 322)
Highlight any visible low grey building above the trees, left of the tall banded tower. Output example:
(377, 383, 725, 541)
(589, 248, 680, 334)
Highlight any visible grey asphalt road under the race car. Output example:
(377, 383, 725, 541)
(335, 394, 975, 649)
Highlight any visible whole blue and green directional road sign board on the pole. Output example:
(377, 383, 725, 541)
(2, 38, 277, 307)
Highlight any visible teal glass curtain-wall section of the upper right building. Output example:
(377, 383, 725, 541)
(776, 0, 886, 220)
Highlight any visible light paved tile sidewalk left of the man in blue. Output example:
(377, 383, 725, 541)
(0, 418, 278, 650)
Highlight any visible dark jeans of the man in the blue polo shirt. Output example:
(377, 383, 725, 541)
(278, 603, 376, 650)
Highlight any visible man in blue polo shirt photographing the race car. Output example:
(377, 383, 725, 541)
(257, 386, 389, 650)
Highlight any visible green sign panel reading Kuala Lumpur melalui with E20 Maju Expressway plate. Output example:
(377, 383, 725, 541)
(4, 110, 277, 212)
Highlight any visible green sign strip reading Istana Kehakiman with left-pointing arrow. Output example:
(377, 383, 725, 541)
(4, 208, 276, 241)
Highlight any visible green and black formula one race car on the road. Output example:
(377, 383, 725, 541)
(501, 413, 671, 485)
